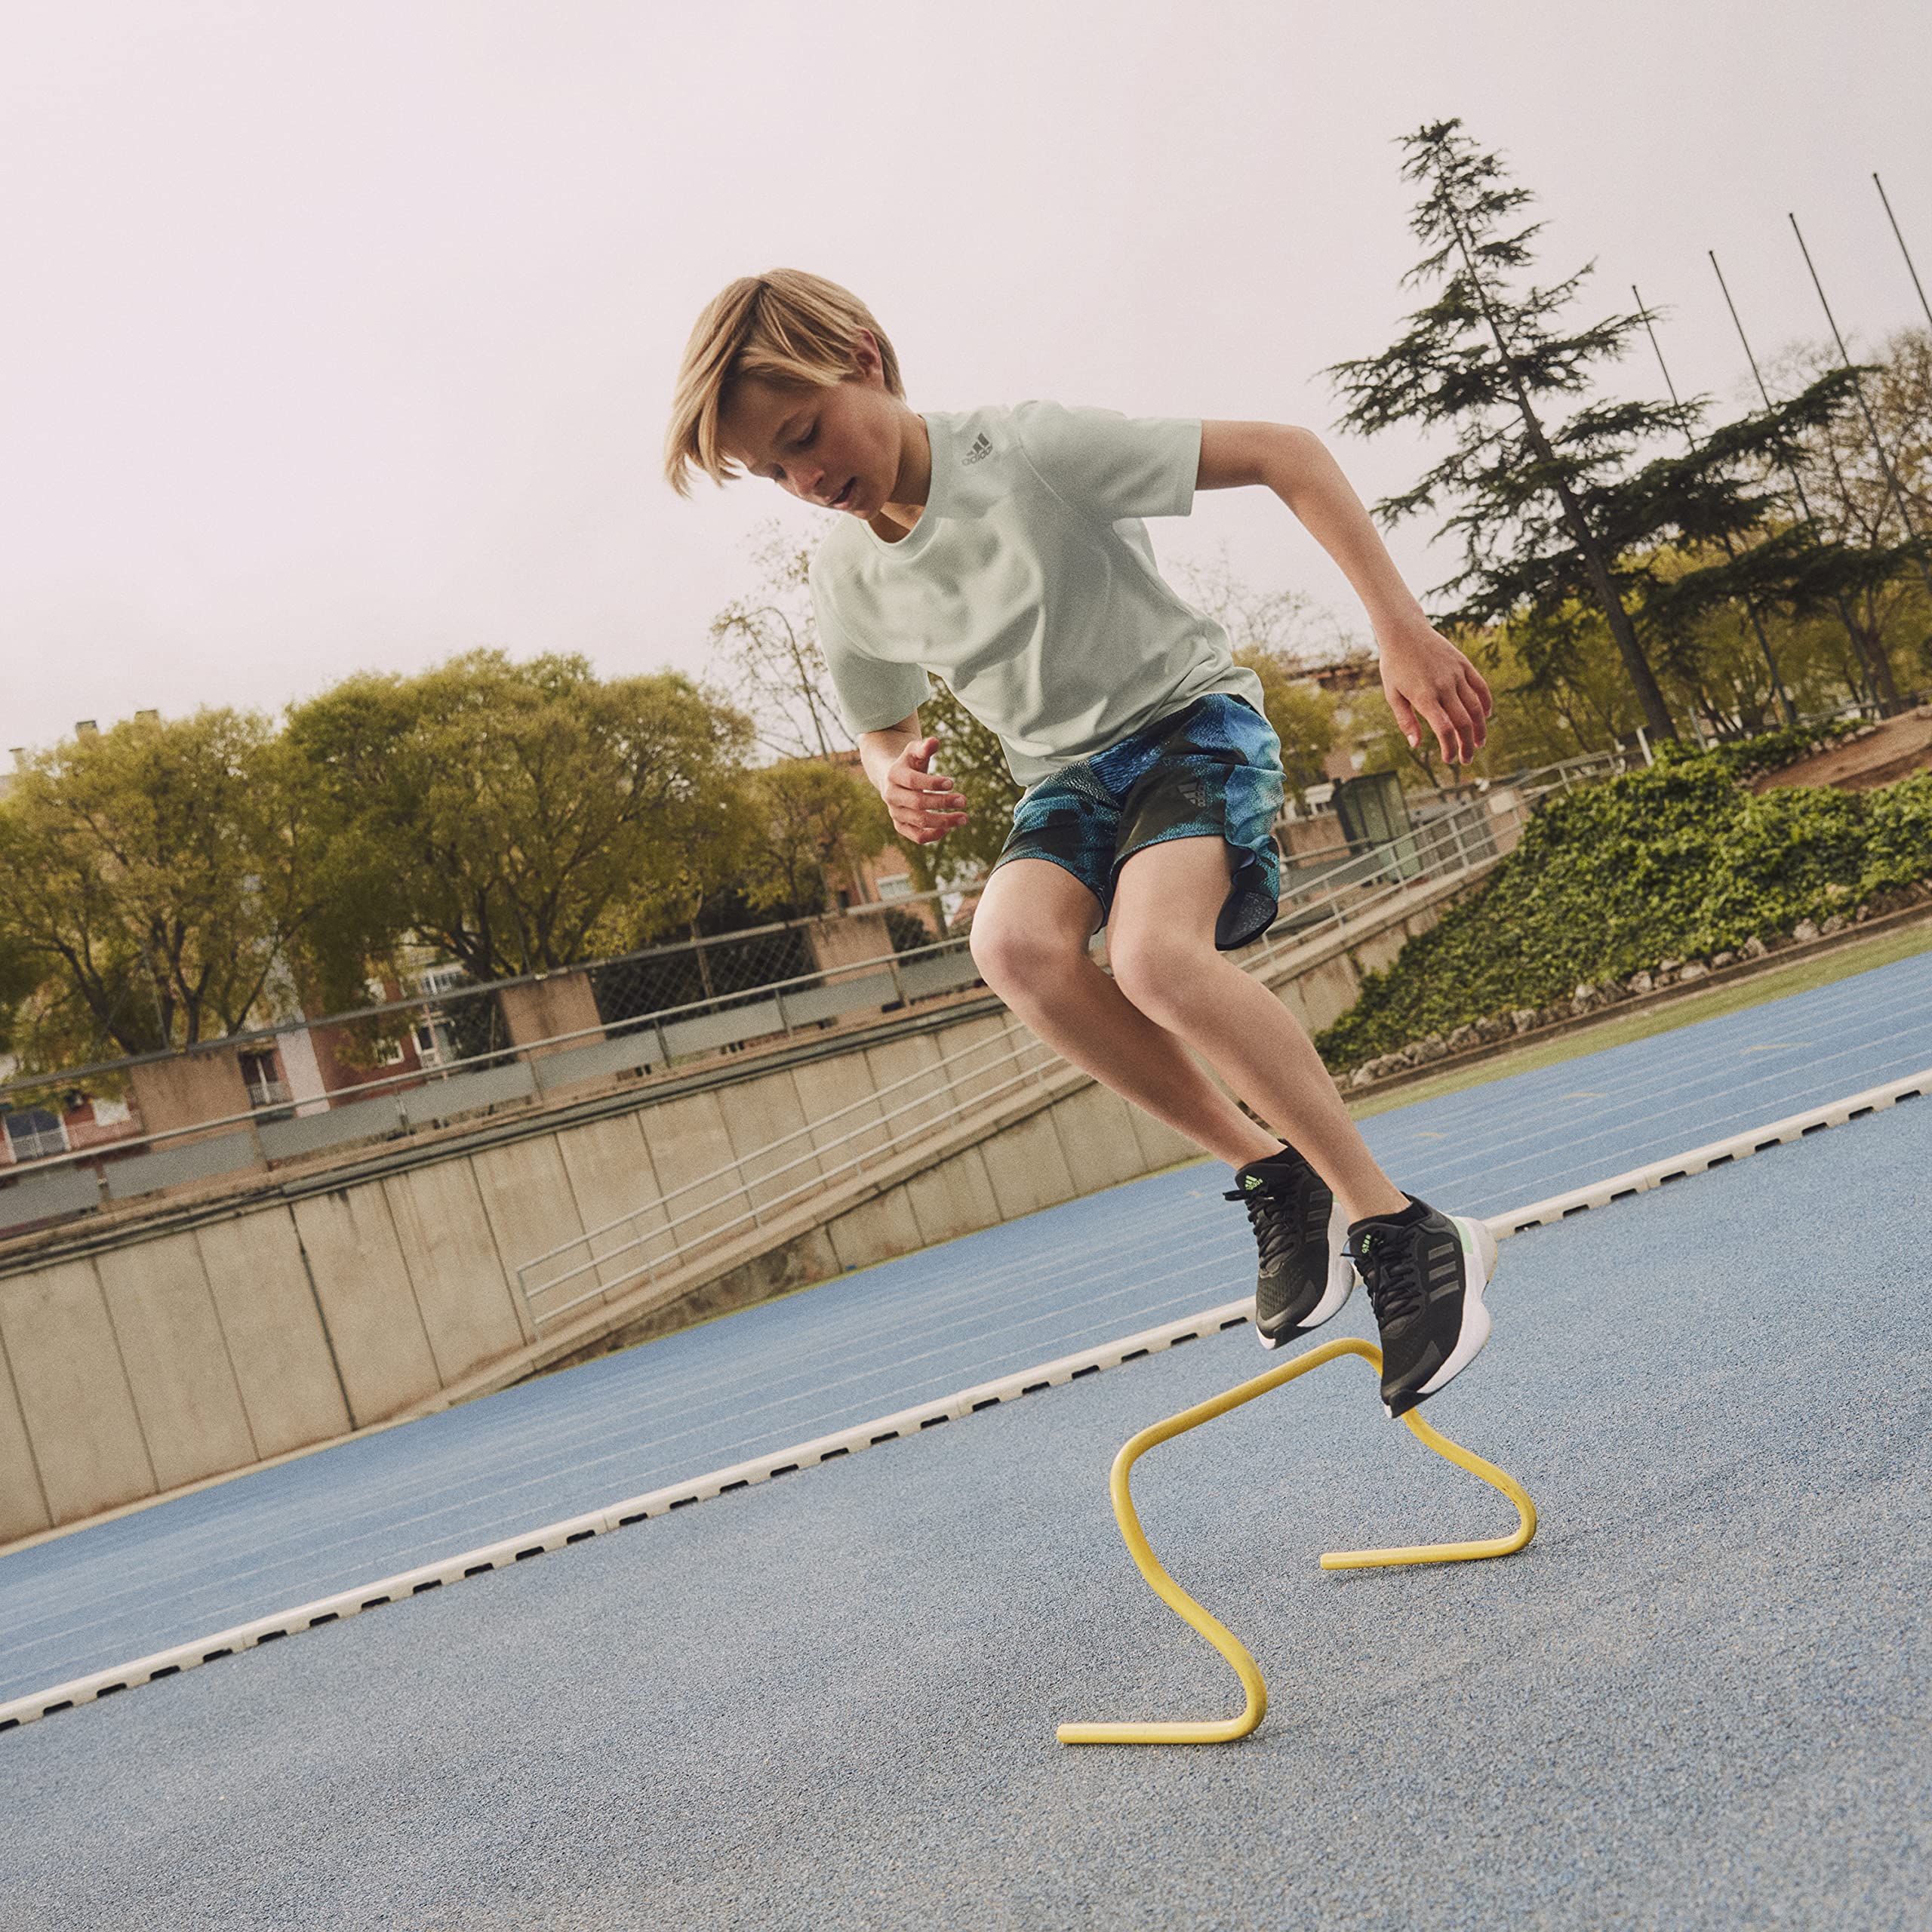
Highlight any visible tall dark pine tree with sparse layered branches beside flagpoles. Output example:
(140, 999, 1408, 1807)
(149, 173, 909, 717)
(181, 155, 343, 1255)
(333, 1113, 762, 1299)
(1329, 120, 1899, 736)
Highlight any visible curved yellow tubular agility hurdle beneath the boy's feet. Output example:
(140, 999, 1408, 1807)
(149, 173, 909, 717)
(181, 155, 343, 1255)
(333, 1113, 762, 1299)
(1057, 1337, 1536, 1745)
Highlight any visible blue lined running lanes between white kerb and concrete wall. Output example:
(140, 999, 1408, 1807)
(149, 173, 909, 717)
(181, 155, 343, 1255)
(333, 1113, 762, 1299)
(0, 952, 1932, 1702)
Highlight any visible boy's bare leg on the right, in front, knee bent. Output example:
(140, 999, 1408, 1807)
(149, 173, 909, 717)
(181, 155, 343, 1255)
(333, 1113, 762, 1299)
(1107, 838, 1408, 1221)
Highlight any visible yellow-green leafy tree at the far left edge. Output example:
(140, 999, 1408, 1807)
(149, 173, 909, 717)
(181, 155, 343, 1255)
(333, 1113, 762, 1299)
(0, 711, 338, 1069)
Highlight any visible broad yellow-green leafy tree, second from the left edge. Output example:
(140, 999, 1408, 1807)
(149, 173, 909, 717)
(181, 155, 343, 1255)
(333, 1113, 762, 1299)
(288, 651, 753, 980)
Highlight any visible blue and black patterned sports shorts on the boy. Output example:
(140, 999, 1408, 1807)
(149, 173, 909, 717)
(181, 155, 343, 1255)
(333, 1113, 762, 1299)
(995, 691, 1281, 952)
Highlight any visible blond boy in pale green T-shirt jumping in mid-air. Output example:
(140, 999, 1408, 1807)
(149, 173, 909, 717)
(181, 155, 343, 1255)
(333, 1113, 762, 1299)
(665, 269, 1495, 1416)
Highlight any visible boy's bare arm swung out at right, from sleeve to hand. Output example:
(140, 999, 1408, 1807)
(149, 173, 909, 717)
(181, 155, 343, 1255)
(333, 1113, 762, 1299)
(1194, 423, 1490, 765)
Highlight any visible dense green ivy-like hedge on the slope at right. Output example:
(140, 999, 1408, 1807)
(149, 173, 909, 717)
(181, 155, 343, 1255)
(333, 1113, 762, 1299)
(1315, 732, 1932, 1069)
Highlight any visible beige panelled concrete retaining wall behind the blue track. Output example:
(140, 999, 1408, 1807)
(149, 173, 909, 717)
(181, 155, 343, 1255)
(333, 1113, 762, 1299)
(0, 897, 1449, 1543)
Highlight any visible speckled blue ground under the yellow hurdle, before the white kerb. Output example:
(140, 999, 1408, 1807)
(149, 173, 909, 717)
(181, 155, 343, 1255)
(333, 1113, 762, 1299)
(0, 1020, 1932, 1932)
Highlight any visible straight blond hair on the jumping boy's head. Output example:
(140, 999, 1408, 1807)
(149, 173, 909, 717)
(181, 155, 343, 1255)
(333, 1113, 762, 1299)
(665, 269, 906, 497)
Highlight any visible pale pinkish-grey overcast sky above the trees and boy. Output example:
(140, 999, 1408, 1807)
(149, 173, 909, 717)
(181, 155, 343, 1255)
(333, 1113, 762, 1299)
(0, 0, 1932, 746)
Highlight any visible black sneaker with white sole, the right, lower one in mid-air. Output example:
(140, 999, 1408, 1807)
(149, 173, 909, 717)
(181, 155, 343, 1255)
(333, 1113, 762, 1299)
(1349, 1194, 1495, 1416)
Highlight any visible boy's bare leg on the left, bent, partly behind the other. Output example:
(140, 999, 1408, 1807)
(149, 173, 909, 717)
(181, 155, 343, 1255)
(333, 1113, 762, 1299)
(972, 858, 1282, 1184)
